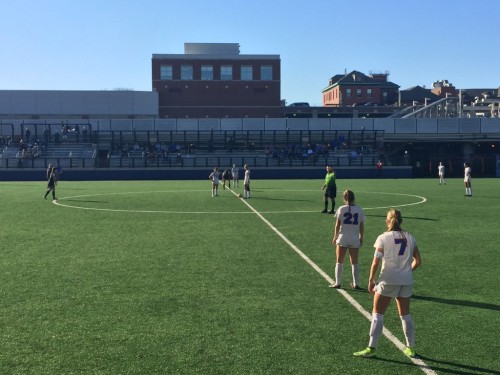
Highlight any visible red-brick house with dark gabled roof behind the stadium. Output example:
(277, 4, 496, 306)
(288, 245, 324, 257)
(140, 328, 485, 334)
(322, 70, 399, 107)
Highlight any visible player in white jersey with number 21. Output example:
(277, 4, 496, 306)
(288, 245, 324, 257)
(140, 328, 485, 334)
(330, 190, 365, 289)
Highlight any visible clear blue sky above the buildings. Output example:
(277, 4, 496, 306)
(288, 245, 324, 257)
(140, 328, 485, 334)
(0, 0, 500, 105)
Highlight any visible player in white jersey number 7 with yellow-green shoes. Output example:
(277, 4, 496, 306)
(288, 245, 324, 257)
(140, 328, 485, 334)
(353, 209, 421, 358)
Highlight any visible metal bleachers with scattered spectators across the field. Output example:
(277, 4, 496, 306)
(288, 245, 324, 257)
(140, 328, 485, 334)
(0, 125, 383, 169)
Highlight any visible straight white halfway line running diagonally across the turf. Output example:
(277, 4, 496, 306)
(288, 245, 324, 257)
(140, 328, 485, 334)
(232, 192, 437, 375)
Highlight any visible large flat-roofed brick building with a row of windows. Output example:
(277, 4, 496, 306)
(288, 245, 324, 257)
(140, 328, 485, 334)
(152, 43, 281, 118)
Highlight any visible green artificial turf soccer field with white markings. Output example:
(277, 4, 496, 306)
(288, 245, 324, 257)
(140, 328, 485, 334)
(0, 179, 500, 375)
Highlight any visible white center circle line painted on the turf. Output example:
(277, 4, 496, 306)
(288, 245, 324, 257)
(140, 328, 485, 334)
(52, 189, 427, 214)
